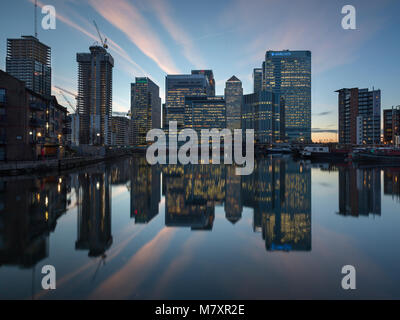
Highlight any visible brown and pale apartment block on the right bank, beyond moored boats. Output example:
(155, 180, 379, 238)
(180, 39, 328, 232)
(336, 88, 381, 145)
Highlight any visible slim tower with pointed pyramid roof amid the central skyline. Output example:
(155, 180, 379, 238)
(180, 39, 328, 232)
(225, 76, 243, 130)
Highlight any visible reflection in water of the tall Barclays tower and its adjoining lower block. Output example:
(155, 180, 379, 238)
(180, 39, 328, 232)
(243, 158, 312, 251)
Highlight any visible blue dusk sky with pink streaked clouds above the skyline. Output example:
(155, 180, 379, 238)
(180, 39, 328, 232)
(0, 0, 400, 141)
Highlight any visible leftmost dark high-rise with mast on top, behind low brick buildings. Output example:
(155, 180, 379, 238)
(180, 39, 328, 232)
(6, 36, 51, 97)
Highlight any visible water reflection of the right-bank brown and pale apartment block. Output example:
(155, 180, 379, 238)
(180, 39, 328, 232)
(339, 167, 381, 217)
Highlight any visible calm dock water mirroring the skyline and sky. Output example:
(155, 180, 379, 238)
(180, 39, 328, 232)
(0, 157, 400, 299)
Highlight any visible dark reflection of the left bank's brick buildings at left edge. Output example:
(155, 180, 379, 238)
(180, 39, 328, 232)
(0, 177, 68, 269)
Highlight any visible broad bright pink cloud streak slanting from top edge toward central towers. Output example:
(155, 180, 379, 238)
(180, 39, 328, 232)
(89, 0, 180, 73)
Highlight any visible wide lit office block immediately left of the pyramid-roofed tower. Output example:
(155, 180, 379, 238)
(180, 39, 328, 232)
(185, 97, 226, 134)
